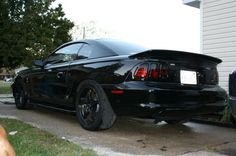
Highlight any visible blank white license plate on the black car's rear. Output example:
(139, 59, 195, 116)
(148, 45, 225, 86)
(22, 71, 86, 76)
(180, 70, 197, 85)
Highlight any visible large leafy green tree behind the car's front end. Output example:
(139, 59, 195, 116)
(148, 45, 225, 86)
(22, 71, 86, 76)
(0, 0, 74, 68)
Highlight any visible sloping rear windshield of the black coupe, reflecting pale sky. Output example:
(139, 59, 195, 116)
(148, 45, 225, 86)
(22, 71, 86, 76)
(99, 40, 149, 55)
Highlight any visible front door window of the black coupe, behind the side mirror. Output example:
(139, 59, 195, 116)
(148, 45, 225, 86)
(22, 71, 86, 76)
(47, 43, 82, 64)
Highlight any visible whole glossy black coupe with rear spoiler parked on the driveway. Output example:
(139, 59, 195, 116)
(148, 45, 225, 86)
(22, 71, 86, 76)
(12, 39, 226, 130)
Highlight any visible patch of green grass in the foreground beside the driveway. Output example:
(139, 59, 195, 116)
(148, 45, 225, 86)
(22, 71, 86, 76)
(0, 118, 96, 156)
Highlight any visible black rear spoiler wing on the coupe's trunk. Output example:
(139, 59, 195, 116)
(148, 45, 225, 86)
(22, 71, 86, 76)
(129, 50, 222, 64)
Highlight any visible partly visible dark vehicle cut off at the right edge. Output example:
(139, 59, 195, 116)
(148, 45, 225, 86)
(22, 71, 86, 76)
(229, 70, 236, 124)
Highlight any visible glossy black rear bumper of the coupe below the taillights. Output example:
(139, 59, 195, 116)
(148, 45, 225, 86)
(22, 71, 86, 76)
(104, 82, 226, 119)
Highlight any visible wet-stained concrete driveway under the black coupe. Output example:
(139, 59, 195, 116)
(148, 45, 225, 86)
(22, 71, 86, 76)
(0, 102, 236, 156)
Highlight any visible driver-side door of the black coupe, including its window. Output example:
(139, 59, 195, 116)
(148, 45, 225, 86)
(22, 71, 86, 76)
(30, 43, 81, 109)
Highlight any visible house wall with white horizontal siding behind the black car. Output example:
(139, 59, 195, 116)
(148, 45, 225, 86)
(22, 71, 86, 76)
(183, 0, 236, 90)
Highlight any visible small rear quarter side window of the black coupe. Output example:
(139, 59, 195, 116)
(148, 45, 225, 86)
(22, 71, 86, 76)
(78, 44, 114, 59)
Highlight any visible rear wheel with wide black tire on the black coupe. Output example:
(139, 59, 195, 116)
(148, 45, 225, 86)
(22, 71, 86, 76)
(76, 80, 116, 131)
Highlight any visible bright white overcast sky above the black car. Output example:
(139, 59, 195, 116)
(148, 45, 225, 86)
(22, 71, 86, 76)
(54, 0, 200, 53)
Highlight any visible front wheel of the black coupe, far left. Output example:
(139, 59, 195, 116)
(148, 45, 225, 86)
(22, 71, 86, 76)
(14, 80, 27, 109)
